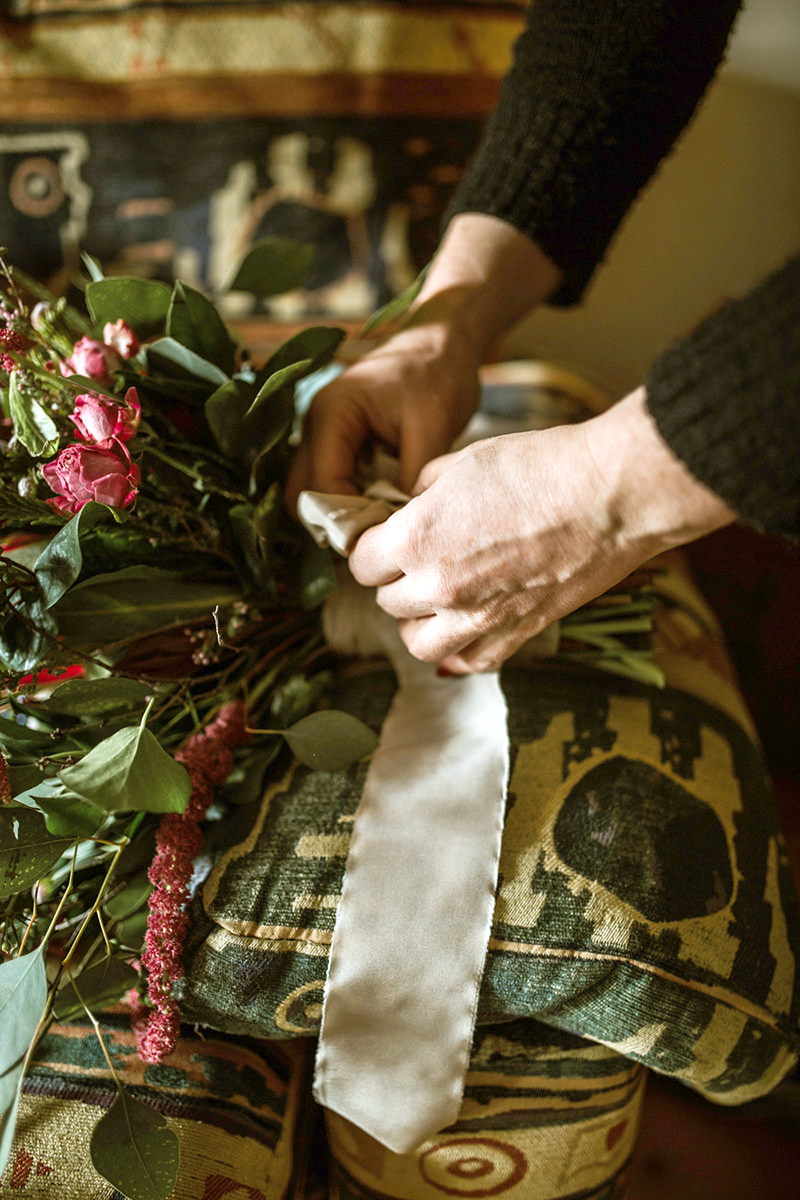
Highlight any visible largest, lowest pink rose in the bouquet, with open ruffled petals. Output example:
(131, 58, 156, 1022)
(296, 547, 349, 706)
(42, 442, 142, 512)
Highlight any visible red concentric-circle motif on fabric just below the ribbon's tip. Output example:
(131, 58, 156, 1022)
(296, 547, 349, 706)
(419, 1138, 528, 1196)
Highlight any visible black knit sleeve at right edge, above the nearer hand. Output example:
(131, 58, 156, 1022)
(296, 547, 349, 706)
(646, 254, 800, 538)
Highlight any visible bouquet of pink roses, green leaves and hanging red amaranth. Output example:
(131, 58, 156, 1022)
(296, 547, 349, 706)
(0, 240, 657, 1200)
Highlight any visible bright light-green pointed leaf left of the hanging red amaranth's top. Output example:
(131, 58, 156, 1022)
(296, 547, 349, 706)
(59, 726, 192, 812)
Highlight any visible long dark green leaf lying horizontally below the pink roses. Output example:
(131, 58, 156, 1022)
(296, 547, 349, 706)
(52, 566, 241, 649)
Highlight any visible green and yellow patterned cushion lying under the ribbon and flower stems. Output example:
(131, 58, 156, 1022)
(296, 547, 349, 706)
(184, 547, 799, 1103)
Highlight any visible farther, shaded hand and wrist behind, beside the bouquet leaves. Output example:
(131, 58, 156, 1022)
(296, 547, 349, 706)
(287, 212, 561, 511)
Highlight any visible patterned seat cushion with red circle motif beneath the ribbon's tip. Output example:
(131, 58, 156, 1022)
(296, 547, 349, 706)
(326, 1021, 646, 1200)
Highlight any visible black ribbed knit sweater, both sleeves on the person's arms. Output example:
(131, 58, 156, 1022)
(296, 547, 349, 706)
(450, 0, 800, 536)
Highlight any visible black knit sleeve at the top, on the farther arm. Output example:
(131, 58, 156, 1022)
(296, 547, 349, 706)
(449, 0, 740, 305)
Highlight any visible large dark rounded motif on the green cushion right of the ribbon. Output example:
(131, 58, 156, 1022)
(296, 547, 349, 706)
(553, 755, 733, 922)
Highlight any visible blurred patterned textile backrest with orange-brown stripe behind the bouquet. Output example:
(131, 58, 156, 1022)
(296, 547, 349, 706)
(0, 0, 525, 320)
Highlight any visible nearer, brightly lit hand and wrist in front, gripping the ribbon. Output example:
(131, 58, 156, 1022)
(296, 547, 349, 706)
(349, 389, 735, 673)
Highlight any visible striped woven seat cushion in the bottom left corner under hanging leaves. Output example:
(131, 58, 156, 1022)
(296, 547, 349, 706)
(0, 1013, 303, 1200)
